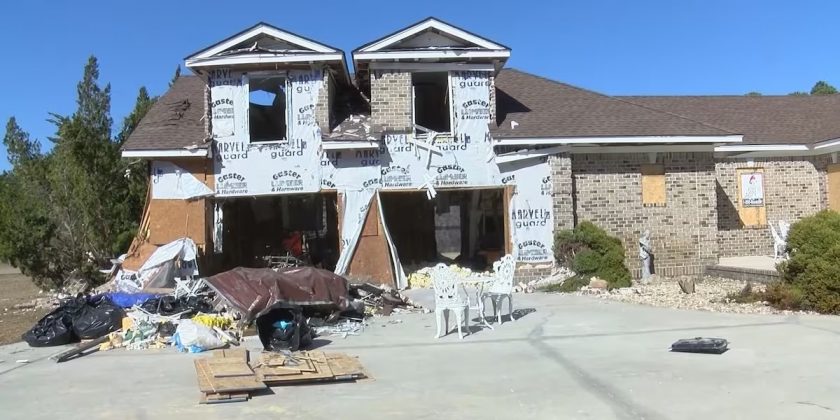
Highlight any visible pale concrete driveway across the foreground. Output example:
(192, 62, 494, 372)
(0, 294, 840, 420)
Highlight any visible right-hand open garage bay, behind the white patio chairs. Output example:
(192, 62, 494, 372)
(380, 188, 506, 272)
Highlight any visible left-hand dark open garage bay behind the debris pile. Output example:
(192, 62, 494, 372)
(215, 193, 339, 271)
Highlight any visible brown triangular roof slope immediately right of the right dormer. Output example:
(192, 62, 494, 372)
(491, 69, 735, 138)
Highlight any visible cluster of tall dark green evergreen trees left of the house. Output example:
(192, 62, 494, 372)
(0, 57, 155, 287)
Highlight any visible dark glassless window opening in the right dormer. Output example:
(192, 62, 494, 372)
(411, 72, 452, 133)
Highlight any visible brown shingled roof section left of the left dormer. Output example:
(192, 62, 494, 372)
(122, 76, 207, 150)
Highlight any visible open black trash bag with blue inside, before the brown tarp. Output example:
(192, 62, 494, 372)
(257, 305, 312, 351)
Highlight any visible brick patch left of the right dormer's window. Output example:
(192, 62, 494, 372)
(370, 70, 412, 132)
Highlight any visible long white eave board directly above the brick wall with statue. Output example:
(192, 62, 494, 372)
(493, 135, 743, 146)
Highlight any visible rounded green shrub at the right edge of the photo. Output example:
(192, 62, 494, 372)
(768, 210, 840, 314)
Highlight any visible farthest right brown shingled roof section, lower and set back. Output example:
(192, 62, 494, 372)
(621, 95, 840, 144)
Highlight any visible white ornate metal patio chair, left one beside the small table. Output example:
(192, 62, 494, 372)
(431, 264, 470, 339)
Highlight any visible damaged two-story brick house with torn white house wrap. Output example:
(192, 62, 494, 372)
(123, 18, 840, 287)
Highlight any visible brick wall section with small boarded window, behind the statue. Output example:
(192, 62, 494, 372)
(568, 153, 717, 276)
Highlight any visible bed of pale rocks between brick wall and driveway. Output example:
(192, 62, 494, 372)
(575, 276, 808, 314)
